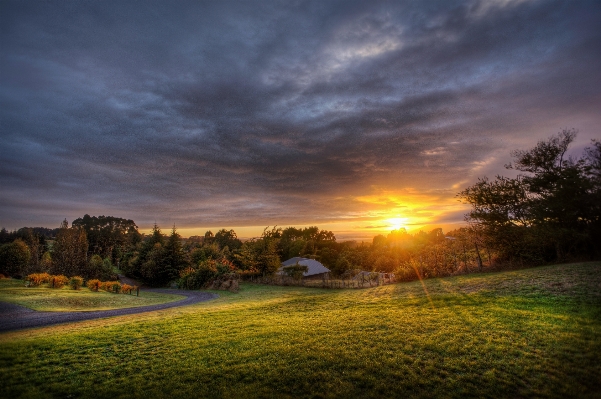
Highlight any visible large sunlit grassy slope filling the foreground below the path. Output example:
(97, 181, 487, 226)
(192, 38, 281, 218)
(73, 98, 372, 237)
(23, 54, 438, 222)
(0, 262, 601, 398)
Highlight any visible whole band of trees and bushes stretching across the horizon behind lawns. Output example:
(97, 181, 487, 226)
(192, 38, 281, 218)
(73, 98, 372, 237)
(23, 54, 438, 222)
(0, 130, 601, 289)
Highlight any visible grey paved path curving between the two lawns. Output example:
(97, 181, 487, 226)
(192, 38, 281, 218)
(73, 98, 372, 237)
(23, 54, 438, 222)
(0, 289, 219, 332)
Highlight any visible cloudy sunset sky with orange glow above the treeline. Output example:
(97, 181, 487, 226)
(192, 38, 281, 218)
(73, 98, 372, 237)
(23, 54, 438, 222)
(0, 0, 601, 240)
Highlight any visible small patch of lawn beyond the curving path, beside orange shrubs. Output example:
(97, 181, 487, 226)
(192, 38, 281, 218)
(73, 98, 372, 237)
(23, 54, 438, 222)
(0, 279, 184, 312)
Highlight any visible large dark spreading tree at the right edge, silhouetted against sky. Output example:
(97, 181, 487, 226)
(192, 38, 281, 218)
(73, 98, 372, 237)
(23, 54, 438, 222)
(459, 130, 601, 264)
